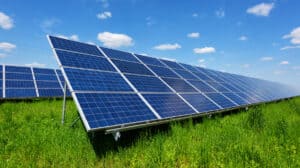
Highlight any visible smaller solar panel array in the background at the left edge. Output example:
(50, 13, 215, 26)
(0, 65, 70, 99)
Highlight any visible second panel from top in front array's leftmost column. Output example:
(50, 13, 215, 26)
(56, 50, 116, 71)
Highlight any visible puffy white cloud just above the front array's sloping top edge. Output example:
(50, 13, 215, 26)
(97, 32, 133, 48)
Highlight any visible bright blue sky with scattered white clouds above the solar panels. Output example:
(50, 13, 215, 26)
(0, 0, 300, 87)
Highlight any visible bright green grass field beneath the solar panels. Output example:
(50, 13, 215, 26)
(0, 98, 300, 167)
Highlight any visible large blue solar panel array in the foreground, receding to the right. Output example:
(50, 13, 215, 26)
(49, 36, 299, 131)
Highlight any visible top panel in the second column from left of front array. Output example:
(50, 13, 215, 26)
(100, 47, 139, 62)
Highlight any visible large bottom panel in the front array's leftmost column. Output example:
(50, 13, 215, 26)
(76, 93, 156, 129)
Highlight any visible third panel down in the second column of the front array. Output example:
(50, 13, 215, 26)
(125, 74, 172, 92)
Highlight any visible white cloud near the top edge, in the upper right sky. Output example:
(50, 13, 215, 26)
(247, 3, 274, 16)
